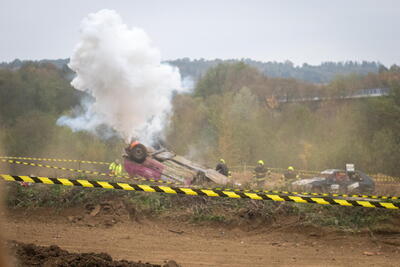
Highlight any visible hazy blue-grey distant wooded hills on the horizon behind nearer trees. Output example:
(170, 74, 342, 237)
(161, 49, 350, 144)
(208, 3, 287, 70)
(0, 58, 385, 83)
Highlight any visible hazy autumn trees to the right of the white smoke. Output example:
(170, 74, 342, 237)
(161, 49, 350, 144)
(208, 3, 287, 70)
(167, 63, 400, 175)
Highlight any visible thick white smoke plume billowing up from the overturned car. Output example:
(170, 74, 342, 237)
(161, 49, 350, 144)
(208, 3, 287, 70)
(58, 10, 184, 144)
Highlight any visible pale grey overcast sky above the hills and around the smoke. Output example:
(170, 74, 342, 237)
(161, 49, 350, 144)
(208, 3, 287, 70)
(0, 0, 400, 65)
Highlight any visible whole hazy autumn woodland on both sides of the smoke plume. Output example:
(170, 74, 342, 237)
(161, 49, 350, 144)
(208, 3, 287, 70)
(0, 61, 400, 176)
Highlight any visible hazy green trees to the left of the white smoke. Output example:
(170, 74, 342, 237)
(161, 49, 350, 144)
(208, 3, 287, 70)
(0, 62, 123, 160)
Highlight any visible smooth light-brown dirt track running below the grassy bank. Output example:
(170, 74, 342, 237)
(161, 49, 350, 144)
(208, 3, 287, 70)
(4, 211, 400, 266)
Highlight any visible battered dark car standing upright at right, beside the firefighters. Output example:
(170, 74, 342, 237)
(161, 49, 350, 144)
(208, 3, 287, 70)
(292, 169, 375, 194)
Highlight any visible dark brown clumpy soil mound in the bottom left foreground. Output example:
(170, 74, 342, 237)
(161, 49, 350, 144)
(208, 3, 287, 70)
(10, 241, 179, 267)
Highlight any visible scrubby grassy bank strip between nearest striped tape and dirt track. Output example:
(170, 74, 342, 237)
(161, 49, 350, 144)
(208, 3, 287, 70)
(6, 183, 398, 230)
